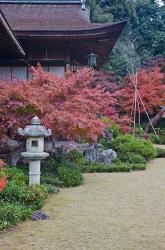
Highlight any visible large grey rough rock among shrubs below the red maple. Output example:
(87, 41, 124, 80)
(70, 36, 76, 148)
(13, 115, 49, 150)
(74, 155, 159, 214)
(84, 148, 117, 164)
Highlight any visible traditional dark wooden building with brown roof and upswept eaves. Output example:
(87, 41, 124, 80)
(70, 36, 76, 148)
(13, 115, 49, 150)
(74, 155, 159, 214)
(0, 0, 125, 80)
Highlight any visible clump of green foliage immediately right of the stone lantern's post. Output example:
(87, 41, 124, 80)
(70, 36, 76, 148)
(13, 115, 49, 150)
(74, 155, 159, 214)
(41, 150, 85, 187)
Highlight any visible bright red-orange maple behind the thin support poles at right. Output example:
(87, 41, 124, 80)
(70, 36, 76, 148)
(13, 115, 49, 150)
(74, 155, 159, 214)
(115, 67, 165, 115)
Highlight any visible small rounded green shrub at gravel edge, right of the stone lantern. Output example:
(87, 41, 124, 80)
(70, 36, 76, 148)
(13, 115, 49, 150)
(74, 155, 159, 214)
(58, 166, 83, 187)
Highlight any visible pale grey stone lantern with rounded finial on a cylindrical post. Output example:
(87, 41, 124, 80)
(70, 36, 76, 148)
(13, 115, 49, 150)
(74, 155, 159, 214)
(18, 116, 52, 186)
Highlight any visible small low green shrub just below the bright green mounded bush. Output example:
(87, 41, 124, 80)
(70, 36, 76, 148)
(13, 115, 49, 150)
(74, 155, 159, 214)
(118, 152, 146, 164)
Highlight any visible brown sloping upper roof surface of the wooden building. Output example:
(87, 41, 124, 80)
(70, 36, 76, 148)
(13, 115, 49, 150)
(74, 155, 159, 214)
(0, 4, 91, 31)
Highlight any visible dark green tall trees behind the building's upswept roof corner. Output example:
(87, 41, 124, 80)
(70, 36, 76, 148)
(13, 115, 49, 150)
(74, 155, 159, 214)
(89, 0, 165, 80)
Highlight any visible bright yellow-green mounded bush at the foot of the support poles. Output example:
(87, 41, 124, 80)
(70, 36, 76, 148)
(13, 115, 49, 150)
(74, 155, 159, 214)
(111, 134, 156, 159)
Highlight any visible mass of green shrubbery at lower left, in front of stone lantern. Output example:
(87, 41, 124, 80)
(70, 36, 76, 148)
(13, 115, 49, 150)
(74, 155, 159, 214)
(0, 167, 53, 230)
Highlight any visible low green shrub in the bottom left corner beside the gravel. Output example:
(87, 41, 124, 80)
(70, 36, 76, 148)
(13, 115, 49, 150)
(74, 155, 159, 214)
(0, 202, 32, 230)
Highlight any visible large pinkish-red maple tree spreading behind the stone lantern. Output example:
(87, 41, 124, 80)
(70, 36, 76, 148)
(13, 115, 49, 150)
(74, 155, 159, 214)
(0, 66, 118, 140)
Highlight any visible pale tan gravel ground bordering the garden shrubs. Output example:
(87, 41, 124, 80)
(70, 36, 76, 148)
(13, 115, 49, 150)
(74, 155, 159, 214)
(0, 155, 165, 250)
